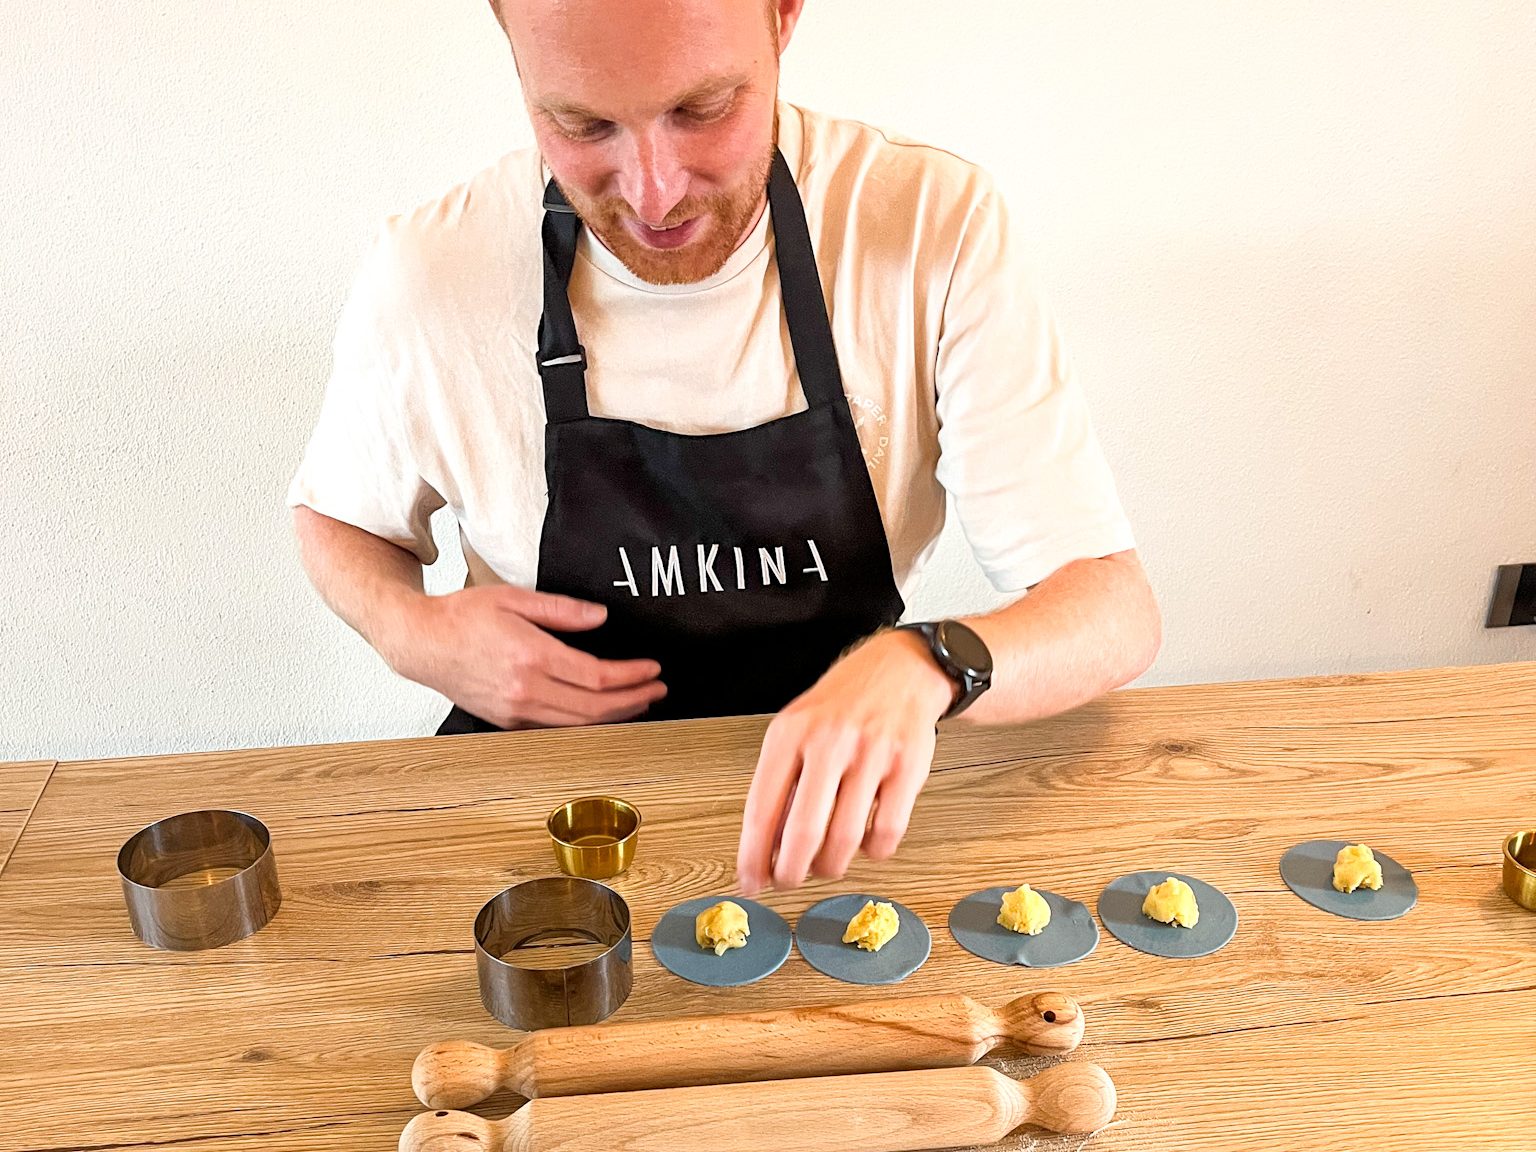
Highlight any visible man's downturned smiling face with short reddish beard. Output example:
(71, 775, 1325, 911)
(501, 0, 800, 284)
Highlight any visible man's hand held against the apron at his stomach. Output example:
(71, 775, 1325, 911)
(384, 585, 667, 728)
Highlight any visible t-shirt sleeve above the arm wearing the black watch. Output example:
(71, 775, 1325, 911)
(935, 187, 1135, 591)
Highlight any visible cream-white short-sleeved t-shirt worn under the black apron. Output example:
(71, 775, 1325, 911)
(289, 104, 1134, 596)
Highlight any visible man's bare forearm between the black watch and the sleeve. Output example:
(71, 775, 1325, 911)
(960, 551, 1163, 723)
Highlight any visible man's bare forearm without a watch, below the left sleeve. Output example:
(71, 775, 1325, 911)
(293, 505, 422, 670)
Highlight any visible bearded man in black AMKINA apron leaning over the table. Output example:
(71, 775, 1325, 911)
(289, 0, 1160, 894)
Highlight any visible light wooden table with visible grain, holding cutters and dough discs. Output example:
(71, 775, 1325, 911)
(0, 664, 1536, 1152)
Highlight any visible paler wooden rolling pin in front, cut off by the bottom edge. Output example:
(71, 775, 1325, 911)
(399, 1063, 1115, 1152)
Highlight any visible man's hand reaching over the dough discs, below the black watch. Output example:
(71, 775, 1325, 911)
(736, 631, 955, 895)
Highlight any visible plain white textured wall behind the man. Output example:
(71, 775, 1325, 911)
(0, 0, 1536, 759)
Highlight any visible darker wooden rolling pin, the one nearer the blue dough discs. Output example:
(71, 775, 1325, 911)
(410, 992, 1083, 1107)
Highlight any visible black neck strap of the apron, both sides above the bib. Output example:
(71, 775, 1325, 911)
(538, 149, 846, 424)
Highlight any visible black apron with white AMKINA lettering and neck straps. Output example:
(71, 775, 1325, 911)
(438, 152, 903, 734)
